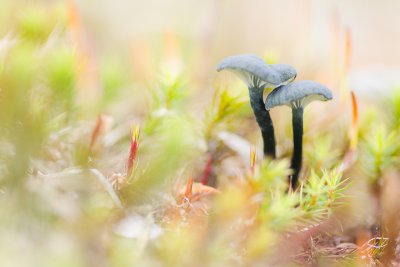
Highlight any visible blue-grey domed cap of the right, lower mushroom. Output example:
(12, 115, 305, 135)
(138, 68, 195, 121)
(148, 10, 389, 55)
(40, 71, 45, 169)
(265, 81, 332, 110)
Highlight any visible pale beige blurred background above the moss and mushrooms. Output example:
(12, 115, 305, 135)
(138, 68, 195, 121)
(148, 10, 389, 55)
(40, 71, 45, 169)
(1, 0, 400, 107)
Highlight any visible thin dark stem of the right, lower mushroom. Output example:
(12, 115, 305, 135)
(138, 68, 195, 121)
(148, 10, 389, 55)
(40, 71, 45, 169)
(289, 106, 303, 190)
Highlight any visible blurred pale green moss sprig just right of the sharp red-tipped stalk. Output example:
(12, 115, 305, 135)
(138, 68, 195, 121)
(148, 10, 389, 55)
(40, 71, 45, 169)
(121, 116, 199, 203)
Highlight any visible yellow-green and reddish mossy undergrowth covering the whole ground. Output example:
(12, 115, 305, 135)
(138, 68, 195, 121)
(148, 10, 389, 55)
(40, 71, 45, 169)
(0, 2, 400, 267)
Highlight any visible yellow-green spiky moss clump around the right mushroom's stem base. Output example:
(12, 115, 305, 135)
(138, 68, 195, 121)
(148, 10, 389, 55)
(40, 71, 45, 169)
(256, 166, 346, 230)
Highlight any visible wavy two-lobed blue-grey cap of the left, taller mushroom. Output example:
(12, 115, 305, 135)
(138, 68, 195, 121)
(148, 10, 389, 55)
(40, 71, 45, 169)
(217, 54, 297, 88)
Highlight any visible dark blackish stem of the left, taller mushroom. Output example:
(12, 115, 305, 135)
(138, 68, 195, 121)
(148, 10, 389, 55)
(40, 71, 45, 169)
(249, 86, 276, 159)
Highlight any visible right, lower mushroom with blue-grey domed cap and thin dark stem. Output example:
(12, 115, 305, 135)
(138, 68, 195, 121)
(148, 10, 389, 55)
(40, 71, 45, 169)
(265, 81, 332, 189)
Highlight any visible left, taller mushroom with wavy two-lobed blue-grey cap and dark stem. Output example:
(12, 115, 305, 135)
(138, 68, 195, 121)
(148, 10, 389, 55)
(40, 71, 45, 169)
(217, 54, 297, 158)
